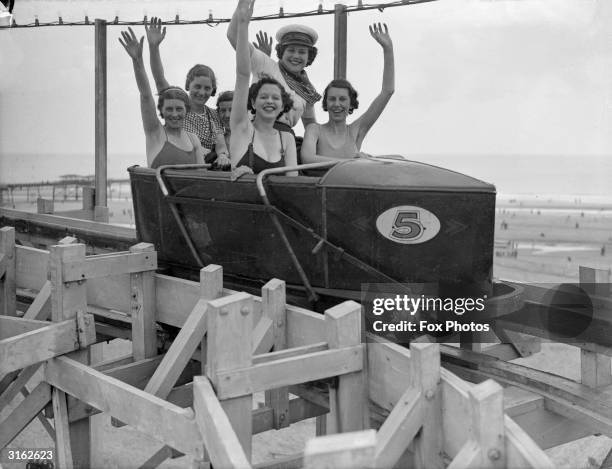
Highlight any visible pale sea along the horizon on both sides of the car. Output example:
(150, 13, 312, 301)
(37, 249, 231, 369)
(0, 153, 612, 202)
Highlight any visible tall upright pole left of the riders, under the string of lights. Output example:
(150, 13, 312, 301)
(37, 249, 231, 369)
(94, 19, 108, 222)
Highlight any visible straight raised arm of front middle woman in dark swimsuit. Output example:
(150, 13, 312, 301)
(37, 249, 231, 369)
(228, 0, 255, 164)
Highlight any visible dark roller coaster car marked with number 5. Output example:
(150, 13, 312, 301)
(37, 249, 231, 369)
(129, 156, 495, 303)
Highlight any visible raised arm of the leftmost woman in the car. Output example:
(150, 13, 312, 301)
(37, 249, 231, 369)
(119, 28, 161, 137)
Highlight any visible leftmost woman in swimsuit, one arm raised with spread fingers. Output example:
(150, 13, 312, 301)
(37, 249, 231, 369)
(119, 28, 204, 168)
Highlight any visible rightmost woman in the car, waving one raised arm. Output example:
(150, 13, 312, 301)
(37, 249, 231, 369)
(301, 23, 395, 163)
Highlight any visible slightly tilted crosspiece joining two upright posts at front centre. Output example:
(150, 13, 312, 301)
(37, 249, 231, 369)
(216, 345, 364, 398)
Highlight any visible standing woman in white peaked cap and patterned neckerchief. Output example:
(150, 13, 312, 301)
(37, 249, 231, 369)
(227, 2, 321, 132)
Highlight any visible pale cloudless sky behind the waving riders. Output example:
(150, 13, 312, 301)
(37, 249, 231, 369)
(0, 0, 612, 190)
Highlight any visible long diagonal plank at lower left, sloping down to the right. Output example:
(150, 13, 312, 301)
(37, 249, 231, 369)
(45, 357, 202, 456)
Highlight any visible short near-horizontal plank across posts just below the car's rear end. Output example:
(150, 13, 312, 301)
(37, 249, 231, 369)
(64, 249, 157, 282)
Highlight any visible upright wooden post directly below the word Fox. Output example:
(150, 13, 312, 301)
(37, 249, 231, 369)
(410, 343, 444, 469)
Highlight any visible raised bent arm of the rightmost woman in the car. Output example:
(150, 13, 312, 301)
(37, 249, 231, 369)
(355, 23, 395, 148)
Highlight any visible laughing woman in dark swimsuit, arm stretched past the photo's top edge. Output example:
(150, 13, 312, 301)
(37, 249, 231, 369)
(230, 0, 297, 176)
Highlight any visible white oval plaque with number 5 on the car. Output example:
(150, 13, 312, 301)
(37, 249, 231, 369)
(376, 205, 440, 244)
